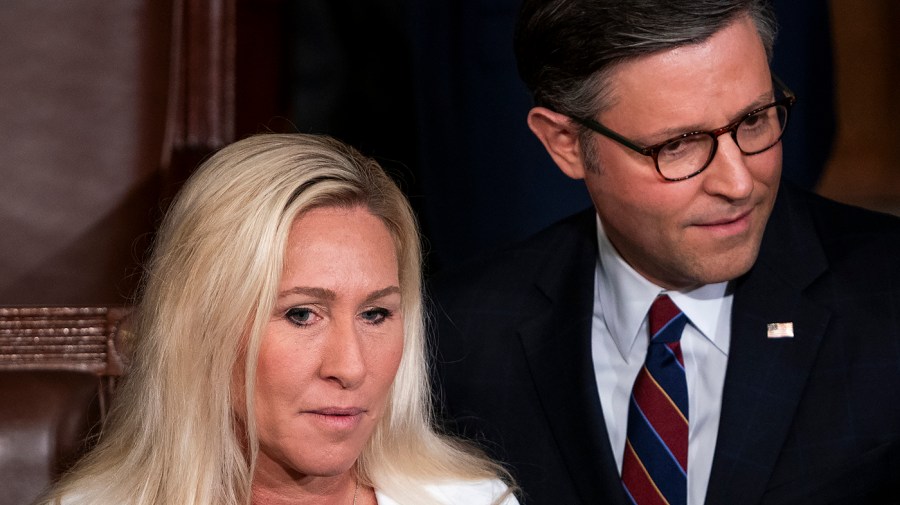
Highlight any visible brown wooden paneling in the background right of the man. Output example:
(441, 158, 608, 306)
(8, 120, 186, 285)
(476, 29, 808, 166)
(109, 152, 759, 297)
(819, 0, 900, 214)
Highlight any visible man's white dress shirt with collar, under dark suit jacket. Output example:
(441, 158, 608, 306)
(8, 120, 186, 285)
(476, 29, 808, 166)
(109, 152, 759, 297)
(591, 214, 733, 505)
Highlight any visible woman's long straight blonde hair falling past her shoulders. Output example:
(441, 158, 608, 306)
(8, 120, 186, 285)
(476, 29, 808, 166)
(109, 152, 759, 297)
(37, 134, 508, 505)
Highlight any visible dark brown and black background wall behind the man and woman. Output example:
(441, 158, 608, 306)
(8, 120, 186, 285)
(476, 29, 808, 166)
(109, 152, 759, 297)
(0, 0, 900, 305)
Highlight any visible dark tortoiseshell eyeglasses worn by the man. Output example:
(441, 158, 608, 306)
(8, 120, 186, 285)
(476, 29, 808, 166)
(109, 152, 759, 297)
(572, 75, 797, 182)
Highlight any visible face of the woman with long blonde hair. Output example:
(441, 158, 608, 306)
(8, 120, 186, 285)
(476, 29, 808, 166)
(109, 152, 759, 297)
(255, 207, 403, 485)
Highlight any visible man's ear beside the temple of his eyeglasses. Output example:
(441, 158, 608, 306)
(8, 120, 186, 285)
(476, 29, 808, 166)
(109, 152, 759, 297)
(528, 107, 584, 179)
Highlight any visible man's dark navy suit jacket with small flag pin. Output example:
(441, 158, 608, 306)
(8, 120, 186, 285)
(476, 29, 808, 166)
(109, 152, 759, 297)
(432, 183, 900, 505)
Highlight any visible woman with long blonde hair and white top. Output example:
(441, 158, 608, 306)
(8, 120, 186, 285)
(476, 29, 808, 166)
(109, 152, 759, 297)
(43, 135, 516, 505)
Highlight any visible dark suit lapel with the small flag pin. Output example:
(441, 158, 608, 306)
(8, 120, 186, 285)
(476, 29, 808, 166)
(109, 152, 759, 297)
(706, 186, 830, 505)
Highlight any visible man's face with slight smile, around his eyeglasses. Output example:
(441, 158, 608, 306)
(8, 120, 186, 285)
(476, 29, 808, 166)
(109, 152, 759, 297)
(584, 18, 781, 289)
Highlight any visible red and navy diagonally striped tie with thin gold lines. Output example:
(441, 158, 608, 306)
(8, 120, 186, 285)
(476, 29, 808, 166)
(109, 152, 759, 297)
(622, 295, 688, 505)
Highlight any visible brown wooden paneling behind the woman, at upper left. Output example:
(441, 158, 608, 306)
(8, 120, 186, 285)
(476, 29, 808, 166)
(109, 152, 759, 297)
(0, 0, 236, 305)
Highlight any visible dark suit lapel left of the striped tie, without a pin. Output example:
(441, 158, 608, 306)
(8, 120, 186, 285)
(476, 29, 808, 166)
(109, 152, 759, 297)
(519, 211, 625, 504)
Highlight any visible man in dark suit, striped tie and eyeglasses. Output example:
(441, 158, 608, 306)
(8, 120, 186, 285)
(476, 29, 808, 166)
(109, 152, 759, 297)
(434, 0, 900, 505)
